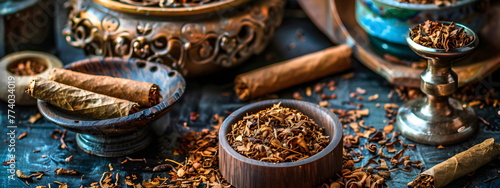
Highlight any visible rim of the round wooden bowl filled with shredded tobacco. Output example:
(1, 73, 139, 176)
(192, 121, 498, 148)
(218, 99, 343, 168)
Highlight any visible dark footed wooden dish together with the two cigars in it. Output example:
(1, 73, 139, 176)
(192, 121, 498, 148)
(34, 57, 186, 157)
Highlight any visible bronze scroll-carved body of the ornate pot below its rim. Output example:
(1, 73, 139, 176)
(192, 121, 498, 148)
(63, 0, 284, 76)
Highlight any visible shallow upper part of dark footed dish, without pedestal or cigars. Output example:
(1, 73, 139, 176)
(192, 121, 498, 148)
(38, 57, 186, 136)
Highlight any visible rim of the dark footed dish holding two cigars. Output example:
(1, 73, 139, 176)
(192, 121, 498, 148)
(37, 57, 186, 134)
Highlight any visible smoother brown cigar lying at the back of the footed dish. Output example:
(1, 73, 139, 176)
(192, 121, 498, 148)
(47, 68, 161, 107)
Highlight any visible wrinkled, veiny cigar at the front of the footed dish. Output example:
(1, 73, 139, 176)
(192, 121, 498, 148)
(26, 77, 139, 119)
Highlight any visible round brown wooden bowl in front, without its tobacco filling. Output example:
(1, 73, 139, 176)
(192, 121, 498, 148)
(219, 99, 342, 188)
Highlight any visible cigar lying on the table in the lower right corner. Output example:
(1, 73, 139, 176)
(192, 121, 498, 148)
(408, 138, 500, 187)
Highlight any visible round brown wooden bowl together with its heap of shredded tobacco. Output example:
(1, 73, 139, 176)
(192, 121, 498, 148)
(219, 99, 342, 188)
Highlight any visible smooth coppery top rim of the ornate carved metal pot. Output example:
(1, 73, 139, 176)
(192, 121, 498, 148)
(92, 0, 250, 16)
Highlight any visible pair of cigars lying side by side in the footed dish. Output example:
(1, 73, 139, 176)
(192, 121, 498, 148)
(26, 68, 161, 119)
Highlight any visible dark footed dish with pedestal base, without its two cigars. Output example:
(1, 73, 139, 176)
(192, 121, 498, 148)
(38, 57, 186, 157)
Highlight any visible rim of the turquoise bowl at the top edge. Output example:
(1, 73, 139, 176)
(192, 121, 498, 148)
(372, 0, 484, 11)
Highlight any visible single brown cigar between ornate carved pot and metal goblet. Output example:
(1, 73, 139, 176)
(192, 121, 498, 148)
(234, 44, 352, 101)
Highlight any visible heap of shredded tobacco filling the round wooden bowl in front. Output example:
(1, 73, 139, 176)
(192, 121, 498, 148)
(226, 103, 330, 163)
